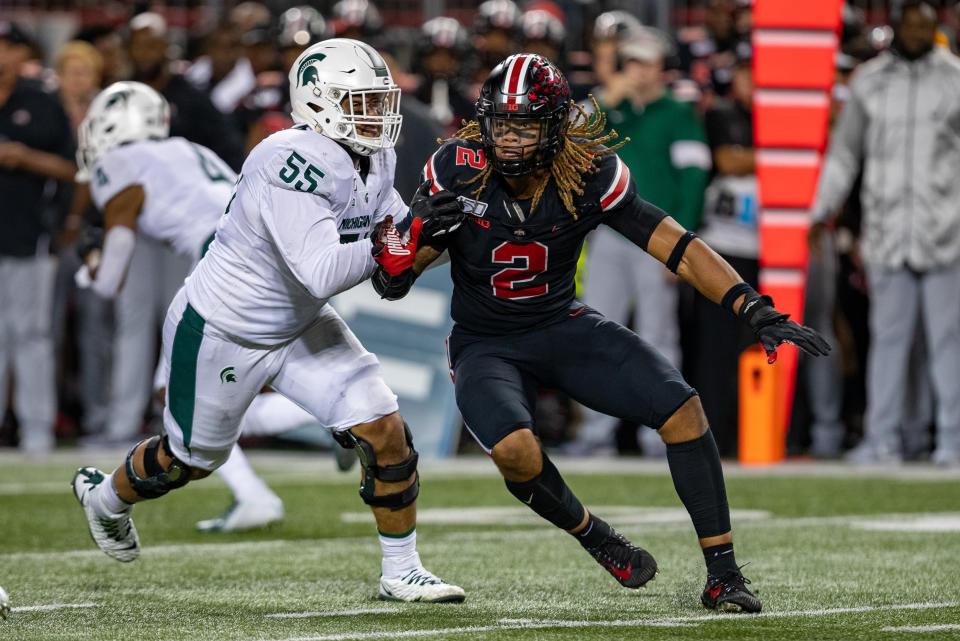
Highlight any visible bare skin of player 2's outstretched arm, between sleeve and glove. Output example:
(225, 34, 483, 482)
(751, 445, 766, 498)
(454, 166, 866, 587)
(647, 217, 743, 313)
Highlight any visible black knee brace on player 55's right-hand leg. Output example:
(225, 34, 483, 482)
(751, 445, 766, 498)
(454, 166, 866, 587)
(342, 422, 420, 511)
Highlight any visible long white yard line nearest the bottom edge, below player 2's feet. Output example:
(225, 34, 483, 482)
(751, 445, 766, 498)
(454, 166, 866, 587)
(262, 601, 960, 641)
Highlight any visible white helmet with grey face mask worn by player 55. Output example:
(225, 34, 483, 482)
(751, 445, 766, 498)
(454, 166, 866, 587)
(290, 38, 403, 156)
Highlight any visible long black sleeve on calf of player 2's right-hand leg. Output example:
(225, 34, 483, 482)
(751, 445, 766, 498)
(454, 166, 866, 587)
(667, 430, 730, 539)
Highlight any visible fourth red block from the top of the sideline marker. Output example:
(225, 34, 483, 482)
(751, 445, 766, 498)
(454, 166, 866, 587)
(756, 149, 820, 209)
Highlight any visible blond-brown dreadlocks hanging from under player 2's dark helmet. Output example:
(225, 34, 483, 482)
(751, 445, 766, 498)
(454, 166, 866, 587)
(453, 96, 630, 218)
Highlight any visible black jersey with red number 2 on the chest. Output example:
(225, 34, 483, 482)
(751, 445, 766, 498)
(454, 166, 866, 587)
(424, 139, 662, 334)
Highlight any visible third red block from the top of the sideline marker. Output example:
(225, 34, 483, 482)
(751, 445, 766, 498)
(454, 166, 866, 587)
(753, 89, 830, 149)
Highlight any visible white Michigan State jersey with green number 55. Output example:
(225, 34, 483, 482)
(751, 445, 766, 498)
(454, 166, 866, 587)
(186, 127, 407, 345)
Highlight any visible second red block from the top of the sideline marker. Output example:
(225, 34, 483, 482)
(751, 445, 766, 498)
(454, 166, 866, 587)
(753, 30, 837, 90)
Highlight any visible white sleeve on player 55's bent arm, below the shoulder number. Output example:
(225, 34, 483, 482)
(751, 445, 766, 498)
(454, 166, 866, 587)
(260, 185, 376, 300)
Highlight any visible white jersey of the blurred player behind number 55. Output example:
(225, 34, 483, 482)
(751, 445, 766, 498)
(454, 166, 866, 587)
(90, 138, 237, 261)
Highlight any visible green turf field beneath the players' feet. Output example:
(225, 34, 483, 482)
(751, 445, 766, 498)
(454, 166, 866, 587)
(0, 453, 960, 641)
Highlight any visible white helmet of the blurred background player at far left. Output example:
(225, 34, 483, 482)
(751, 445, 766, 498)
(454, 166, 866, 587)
(76, 81, 170, 182)
